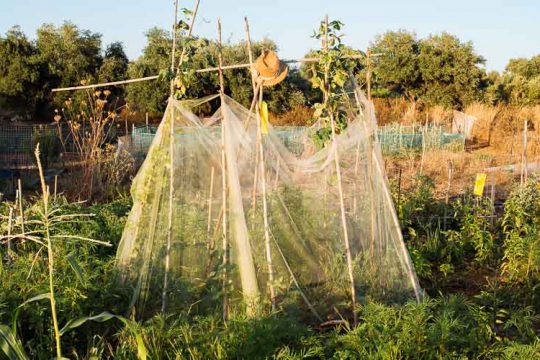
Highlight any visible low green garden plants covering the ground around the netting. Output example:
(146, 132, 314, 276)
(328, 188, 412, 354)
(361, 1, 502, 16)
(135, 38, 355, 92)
(0, 179, 540, 359)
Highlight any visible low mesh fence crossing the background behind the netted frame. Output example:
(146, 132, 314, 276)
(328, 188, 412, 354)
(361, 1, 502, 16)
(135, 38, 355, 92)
(0, 124, 465, 169)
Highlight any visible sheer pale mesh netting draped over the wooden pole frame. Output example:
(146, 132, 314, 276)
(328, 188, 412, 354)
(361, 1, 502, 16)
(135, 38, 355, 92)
(117, 90, 421, 320)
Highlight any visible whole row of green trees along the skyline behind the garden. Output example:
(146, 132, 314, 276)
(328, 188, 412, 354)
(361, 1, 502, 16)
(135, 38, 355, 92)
(0, 22, 540, 122)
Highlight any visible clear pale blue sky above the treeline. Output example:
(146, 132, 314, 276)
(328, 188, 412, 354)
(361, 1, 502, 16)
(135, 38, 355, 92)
(0, 0, 540, 70)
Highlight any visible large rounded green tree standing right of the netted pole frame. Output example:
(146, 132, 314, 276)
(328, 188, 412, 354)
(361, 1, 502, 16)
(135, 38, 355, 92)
(372, 30, 485, 107)
